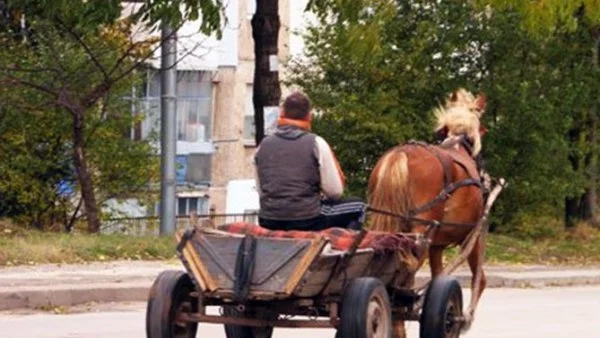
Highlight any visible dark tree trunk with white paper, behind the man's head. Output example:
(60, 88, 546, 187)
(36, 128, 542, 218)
(252, 0, 281, 145)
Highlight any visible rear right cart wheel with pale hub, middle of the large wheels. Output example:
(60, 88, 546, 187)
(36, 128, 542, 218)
(336, 277, 392, 338)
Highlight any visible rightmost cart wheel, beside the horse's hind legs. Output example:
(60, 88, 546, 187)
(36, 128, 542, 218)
(419, 276, 463, 338)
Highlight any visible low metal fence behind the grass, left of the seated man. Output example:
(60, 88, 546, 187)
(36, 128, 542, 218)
(101, 213, 258, 236)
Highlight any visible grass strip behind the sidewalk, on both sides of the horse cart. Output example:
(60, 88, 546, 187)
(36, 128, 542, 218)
(0, 223, 600, 266)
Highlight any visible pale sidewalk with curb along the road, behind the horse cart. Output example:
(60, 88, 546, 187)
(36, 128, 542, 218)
(0, 261, 600, 310)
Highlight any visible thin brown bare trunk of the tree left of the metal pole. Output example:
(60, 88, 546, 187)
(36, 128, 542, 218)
(73, 109, 100, 233)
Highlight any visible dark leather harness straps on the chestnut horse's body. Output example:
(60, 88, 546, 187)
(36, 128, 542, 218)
(367, 137, 483, 226)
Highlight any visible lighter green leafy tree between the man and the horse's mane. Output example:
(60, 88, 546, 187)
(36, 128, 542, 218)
(291, 0, 492, 196)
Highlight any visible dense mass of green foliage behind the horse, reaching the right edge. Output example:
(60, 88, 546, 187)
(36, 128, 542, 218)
(292, 0, 600, 232)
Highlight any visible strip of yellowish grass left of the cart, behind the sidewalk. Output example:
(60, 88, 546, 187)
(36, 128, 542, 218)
(0, 225, 176, 266)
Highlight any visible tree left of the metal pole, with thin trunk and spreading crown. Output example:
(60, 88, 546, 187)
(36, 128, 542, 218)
(0, 0, 222, 232)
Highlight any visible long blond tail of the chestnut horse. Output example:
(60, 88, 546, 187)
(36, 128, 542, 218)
(369, 148, 412, 232)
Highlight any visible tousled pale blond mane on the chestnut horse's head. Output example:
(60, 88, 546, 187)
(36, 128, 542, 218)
(434, 88, 486, 157)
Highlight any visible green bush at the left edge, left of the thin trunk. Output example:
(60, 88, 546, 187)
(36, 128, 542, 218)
(0, 105, 70, 227)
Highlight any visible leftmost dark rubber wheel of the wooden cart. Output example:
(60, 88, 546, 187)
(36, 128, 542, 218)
(146, 270, 198, 338)
